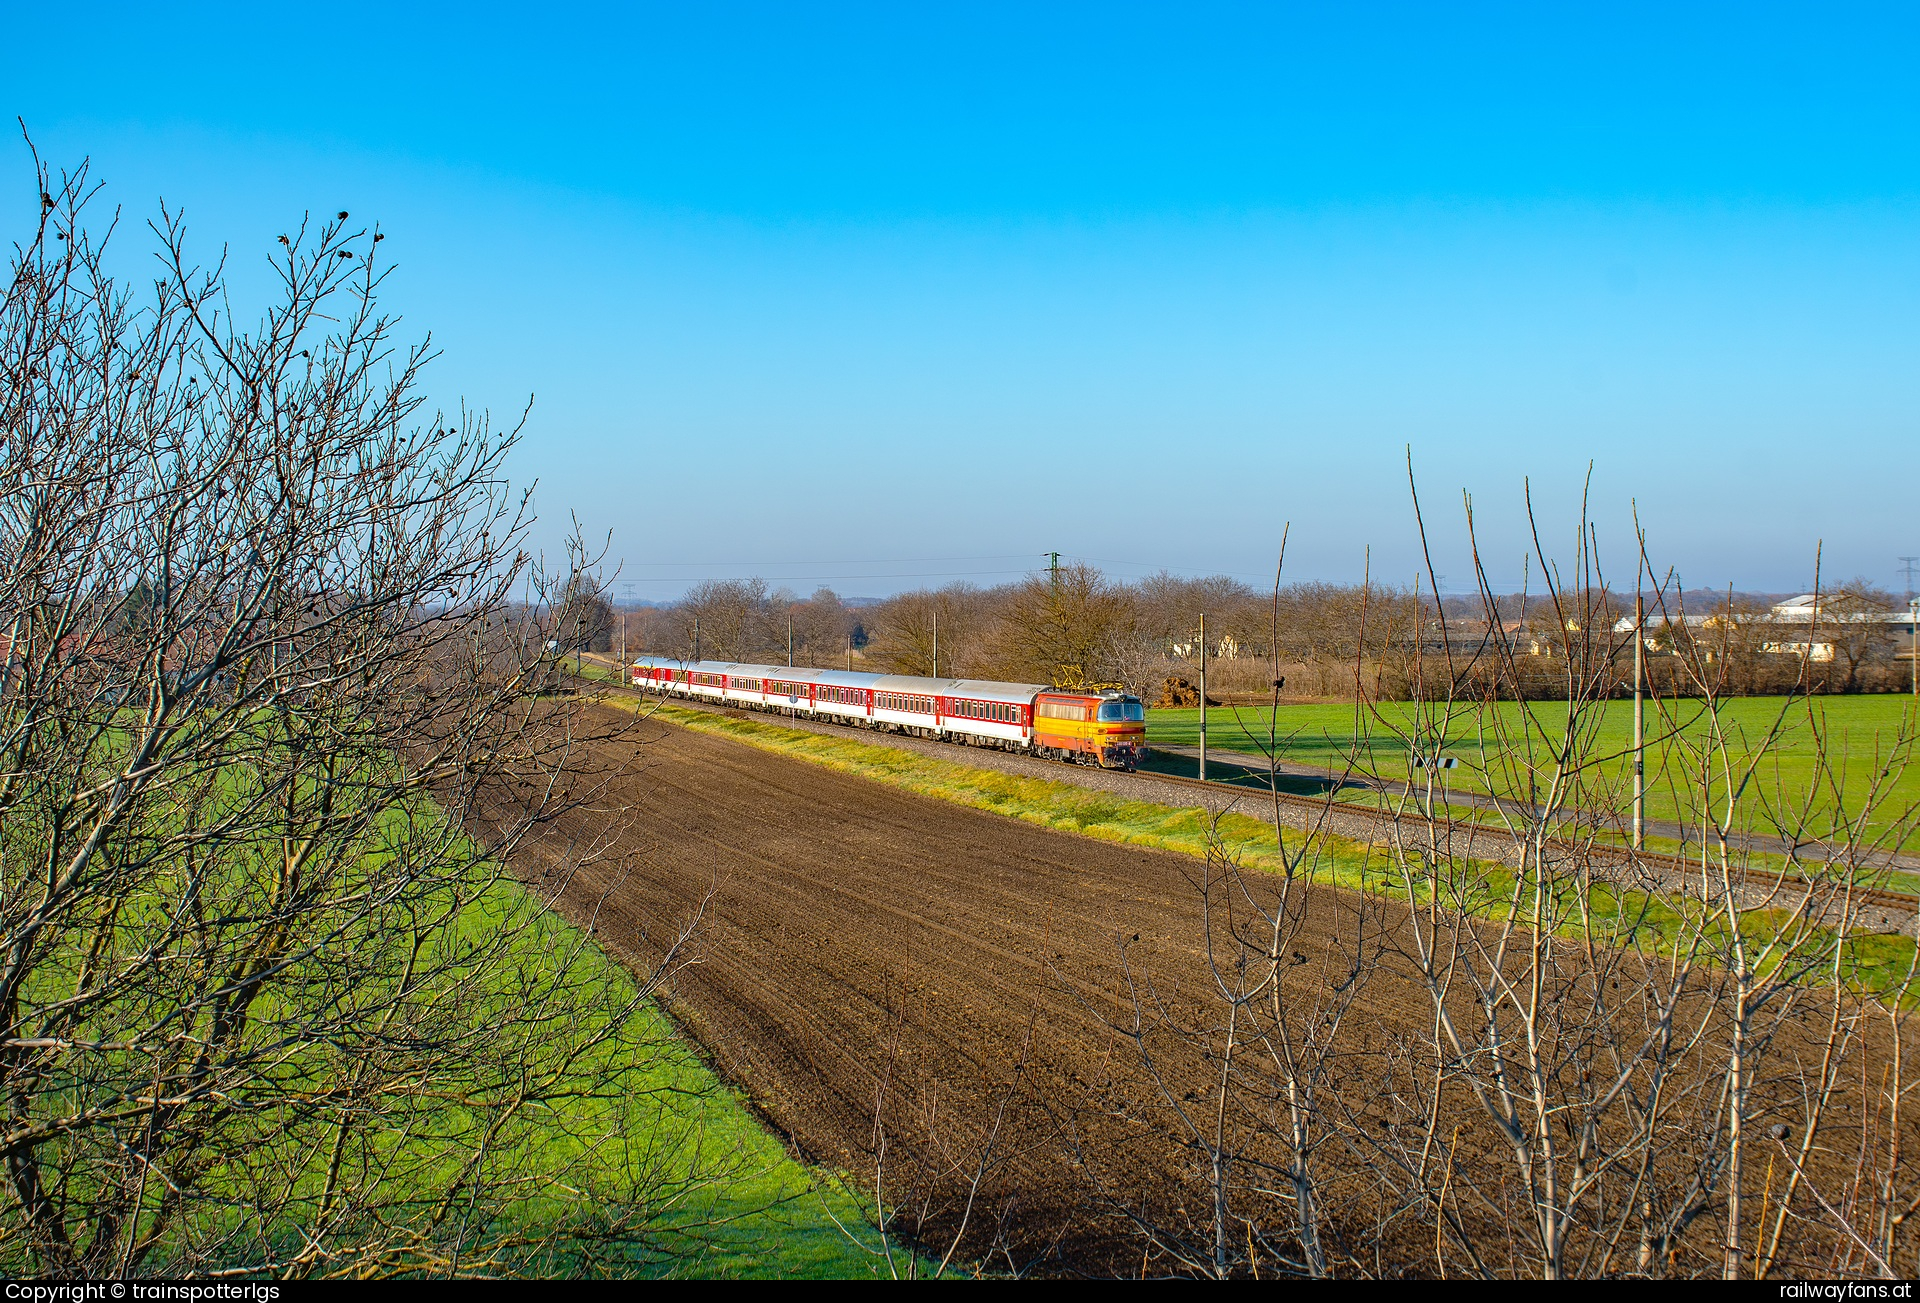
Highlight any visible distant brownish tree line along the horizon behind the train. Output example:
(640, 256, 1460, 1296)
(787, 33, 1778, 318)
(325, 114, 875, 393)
(610, 564, 1907, 700)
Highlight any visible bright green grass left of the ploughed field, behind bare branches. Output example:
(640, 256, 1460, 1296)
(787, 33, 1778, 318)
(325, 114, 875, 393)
(0, 725, 894, 1278)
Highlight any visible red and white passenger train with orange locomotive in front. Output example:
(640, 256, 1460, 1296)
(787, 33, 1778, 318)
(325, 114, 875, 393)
(628, 656, 1146, 771)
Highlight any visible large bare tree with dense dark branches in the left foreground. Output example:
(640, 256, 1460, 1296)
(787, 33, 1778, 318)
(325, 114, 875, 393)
(0, 150, 721, 1276)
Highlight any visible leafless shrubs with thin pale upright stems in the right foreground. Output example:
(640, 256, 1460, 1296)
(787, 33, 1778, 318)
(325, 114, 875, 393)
(1110, 483, 1920, 1278)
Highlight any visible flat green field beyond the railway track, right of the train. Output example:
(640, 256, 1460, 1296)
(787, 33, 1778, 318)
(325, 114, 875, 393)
(1146, 695, 1920, 848)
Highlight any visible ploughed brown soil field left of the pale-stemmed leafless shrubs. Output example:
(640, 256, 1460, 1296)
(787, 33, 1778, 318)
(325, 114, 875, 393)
(503, 708, 1912, 1274)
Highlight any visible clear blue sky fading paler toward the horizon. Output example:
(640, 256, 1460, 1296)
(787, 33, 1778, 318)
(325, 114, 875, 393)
(0, 4, 1920, 597)
